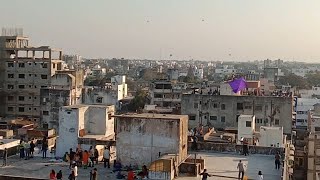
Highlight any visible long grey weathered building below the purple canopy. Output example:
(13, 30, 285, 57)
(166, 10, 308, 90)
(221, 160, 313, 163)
(181, 93, 294, 134)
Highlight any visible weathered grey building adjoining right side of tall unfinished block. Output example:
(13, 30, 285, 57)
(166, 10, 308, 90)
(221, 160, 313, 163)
(40, 70, 84, 130)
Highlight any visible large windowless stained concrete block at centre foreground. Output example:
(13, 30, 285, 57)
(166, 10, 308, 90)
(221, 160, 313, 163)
(117, 117, 187, 165)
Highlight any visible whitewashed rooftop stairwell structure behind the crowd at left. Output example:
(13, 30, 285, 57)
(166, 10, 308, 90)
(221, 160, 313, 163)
(57, 105, 115, 156)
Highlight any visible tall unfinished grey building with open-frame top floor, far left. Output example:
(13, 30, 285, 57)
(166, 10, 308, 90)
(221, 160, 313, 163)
(0, 33, 63, 122)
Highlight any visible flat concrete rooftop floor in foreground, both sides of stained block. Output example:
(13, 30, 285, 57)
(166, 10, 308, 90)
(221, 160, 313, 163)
(0, 152, 281, 180)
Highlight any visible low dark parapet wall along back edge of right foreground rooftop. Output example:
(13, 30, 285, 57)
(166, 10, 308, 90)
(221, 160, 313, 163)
(188, 142, 283, 155)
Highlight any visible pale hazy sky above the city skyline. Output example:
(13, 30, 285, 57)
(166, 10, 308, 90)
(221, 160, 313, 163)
(0, 0, 320, 62)
